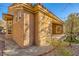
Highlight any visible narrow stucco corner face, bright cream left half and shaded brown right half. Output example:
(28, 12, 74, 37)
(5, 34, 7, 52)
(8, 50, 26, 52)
(24, 11, 34, 46)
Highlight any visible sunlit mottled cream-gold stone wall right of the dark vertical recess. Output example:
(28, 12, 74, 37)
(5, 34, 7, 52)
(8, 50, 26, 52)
(37, 12, 52, 46)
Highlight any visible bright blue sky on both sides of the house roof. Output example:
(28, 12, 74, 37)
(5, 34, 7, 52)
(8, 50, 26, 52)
(0, 3, 79, 21)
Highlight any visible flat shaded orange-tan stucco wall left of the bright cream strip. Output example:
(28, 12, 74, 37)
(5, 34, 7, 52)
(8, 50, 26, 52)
(13, 9, 24, 47)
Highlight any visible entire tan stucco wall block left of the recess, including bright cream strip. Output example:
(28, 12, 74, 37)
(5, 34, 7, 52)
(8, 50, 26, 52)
(13, 10, 34, 47)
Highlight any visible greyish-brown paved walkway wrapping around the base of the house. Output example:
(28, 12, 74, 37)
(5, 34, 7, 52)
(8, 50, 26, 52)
(4, 39, 53, 56)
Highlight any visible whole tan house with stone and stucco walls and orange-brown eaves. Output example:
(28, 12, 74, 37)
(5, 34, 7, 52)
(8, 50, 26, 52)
(3, 3, 63, 47)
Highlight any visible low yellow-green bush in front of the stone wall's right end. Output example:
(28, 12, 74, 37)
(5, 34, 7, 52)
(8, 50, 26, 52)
(48, 39, 72, 56)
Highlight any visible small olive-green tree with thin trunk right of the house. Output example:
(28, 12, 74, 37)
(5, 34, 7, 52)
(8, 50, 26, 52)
(65, 14, 79, 45)
